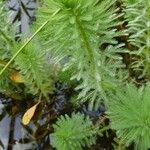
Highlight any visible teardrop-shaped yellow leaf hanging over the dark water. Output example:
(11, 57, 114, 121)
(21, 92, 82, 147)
(22, 102, 40, 125)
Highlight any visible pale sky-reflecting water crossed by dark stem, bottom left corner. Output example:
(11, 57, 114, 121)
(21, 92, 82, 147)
(0, 99, 36, 150)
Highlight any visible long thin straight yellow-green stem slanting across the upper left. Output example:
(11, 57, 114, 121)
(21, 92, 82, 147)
(0, 9, 60, 76)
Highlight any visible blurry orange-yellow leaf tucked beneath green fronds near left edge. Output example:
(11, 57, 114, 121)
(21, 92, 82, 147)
(10, 72, 24, 83)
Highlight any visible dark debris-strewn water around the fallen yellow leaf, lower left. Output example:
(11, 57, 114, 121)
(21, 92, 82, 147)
(0, 82, 73, 150)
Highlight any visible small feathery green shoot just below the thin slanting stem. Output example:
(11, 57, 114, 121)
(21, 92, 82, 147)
(13, 40, 53, 97)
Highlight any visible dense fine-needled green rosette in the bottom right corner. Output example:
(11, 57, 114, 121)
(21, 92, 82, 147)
(107, 84, 150, 150)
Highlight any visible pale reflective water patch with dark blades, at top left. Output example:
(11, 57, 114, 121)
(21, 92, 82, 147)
(7, 0, 38, 35)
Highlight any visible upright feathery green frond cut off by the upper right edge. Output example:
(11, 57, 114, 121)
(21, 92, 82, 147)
(124, 0, 150, 78)
